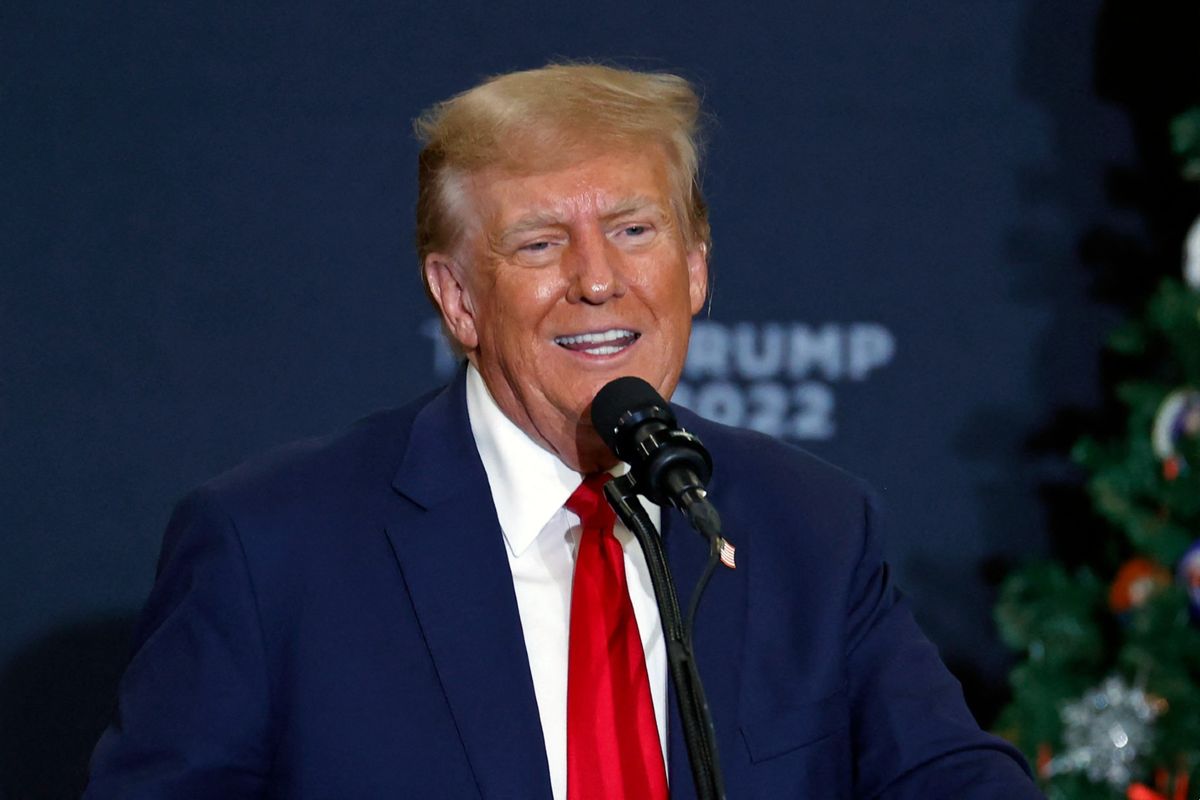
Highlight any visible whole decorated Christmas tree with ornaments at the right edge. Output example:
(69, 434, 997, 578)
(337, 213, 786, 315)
(996, 107, 1200, 800)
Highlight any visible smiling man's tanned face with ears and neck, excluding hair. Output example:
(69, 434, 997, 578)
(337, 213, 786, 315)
(425, 148, 708, 471)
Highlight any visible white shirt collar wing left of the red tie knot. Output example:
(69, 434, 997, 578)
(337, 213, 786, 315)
(467, 366, 582, 557)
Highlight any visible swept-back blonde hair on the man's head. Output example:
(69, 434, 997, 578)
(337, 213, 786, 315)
(414, 64, 712, 293)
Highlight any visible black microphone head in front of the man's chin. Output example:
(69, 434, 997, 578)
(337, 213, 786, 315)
(592, 377, 721, 537)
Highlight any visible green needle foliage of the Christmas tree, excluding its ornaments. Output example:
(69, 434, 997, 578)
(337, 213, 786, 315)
(995, 107, 1200, 800)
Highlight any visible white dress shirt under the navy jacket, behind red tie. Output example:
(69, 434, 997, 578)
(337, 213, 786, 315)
(467, 367, 667, 800)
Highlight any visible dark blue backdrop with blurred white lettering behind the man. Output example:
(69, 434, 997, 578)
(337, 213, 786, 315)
(0, 0, 1130, 796)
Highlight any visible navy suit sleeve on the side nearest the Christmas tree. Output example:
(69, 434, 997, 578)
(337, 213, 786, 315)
(846, 491, 1043, 800)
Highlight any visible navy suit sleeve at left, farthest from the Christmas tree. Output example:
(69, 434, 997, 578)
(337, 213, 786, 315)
(84, 491, 270, 800)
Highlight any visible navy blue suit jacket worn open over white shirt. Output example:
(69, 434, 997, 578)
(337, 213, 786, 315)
(85, 374, 1040, 800)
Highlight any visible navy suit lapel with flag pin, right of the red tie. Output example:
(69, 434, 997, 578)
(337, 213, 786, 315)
(662, 470, 746, 800)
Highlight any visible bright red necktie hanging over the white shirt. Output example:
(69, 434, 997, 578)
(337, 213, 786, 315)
(566, 473, 667, 800)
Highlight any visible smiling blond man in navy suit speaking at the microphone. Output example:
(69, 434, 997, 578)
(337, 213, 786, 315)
(86, 65, 1039, 800)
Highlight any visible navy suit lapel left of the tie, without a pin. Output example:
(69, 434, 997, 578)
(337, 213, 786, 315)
(388, 372, 551, 800)
